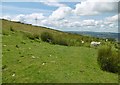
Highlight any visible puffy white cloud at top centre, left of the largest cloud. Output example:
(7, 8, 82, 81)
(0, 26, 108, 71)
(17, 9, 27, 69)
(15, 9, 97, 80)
(49, 6, 72, 20)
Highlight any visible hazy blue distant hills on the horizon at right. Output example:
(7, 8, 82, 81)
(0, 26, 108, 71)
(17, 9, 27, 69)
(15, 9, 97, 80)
(66, 31, 120, 40)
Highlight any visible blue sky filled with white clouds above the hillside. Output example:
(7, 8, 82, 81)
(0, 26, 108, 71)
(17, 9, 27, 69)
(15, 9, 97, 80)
(0, 0, 119, 32)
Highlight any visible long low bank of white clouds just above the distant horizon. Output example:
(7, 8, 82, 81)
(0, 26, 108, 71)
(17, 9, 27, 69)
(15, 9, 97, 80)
(42, 15, 118, 32)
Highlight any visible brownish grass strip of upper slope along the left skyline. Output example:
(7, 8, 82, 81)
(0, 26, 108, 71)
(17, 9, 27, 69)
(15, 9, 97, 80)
(0, 20, 79, 37)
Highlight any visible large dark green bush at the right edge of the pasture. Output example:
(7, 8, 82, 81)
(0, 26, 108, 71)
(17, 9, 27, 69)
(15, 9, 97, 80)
(97, 46, 120, 73)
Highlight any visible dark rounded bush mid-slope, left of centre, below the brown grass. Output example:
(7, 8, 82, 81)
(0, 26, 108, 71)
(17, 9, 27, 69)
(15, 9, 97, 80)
(41, 32, 54, 43)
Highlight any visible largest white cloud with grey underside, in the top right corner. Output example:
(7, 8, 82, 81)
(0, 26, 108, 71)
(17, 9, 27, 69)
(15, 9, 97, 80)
(73, 0, 118, 16)
